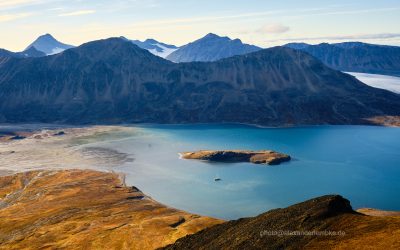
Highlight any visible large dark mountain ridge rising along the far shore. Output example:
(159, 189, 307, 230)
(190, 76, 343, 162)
(0, 38, 400, 126)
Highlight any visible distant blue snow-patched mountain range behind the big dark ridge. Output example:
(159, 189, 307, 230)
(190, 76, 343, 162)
(0, 33, 400, 76)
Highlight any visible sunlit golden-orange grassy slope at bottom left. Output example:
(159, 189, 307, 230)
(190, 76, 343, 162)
(0, 170, 221, 250)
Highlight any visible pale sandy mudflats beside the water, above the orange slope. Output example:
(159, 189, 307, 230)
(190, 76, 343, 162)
(0, 126, 135, 175)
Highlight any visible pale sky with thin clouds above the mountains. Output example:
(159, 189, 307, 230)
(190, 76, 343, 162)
(0, 0, 400, 51)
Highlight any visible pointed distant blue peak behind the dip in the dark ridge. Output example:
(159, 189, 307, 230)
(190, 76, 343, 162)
(166, 33, 261, 62)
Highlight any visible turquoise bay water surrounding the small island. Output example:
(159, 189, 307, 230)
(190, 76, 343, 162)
(96, 125, 400, 219)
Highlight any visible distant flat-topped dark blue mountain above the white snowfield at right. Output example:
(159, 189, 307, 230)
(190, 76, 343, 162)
(285, 42, 400, 76)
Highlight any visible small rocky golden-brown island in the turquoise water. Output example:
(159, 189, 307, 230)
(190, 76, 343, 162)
(181, 150, 291, 165)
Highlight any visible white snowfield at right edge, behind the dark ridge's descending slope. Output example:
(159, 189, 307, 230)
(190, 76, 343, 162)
(345, 72, 400, 94)
